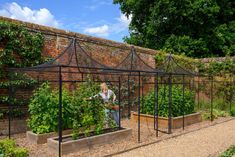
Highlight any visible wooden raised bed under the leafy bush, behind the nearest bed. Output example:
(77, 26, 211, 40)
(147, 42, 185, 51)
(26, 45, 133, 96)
(26, 130, 72, 144)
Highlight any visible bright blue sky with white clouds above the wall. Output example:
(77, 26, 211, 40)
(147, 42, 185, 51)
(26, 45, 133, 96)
(0, 0, 131, 42)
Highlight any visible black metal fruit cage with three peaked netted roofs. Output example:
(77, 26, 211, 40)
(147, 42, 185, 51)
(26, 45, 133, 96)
(4, 38, 234, 156)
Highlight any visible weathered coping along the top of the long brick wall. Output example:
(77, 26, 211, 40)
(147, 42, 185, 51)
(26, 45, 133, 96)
(0, 16, 158, 55)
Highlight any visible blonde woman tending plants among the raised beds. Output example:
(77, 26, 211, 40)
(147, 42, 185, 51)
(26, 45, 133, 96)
(89, 83, 119, 125)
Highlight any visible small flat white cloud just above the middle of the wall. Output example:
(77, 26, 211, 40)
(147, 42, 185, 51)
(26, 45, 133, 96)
(84, 25, 109, 36)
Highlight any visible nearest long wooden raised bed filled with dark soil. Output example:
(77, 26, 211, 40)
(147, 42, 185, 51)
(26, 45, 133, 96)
(47, 128, 132, 155)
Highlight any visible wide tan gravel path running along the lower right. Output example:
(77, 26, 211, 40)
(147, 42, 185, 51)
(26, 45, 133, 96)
(115, 119, 235, 157)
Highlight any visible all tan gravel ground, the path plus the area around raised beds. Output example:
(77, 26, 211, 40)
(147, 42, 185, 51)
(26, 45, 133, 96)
(0, 117, 235, 157)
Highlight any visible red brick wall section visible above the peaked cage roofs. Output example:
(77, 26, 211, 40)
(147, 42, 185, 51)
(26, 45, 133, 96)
(0, 16, 157, 67)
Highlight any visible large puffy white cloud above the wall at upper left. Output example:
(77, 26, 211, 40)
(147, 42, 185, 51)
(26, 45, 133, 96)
(0, 2, 60, 27)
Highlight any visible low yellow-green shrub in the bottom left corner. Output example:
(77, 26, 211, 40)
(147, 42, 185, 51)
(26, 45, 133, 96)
(0, 139, 28, 157)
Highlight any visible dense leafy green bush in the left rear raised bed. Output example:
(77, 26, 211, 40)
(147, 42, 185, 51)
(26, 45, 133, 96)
(28, 83, 73, 134)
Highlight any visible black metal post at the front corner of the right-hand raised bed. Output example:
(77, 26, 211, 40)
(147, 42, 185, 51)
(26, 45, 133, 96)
(168, 74, 172, 134)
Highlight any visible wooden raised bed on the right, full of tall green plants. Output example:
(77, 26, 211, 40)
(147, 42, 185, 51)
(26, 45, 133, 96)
(131, 112, 202, 129)
